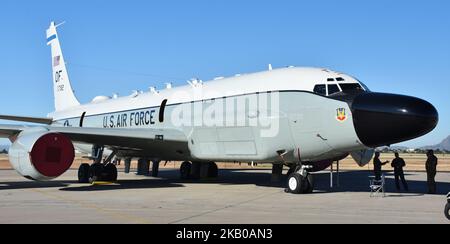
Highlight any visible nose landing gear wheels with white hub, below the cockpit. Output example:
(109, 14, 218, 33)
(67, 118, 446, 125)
(286, 165, 314, 194)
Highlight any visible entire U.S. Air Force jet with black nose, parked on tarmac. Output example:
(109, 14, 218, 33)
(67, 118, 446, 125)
(0, 22, 439, 194)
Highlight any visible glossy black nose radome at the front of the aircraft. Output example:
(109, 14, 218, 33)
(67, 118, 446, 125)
(352, 93, 439, 148)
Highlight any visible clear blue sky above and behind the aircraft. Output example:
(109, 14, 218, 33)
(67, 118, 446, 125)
(0, 0, 450, 147)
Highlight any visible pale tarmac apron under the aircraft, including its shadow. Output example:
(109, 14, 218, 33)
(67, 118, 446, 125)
(0, 169, 450, 224)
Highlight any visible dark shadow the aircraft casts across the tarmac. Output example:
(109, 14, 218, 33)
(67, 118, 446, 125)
(0, 169, 450, 197)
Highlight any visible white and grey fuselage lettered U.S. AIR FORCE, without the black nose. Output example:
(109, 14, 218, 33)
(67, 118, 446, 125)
(49, 68, 366, 163)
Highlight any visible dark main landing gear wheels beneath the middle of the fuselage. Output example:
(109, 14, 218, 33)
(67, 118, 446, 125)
(180, 162, 219, 180)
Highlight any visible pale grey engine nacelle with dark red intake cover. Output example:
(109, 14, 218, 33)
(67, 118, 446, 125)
(9, 128, 75, 181)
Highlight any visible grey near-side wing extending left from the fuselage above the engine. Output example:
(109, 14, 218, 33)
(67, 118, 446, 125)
(0, 125, 189, 157)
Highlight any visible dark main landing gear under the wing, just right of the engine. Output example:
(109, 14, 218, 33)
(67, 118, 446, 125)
(78, 146, 117, 183)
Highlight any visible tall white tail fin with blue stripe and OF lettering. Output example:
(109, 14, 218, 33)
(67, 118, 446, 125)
(47, 22, 80, 111)
